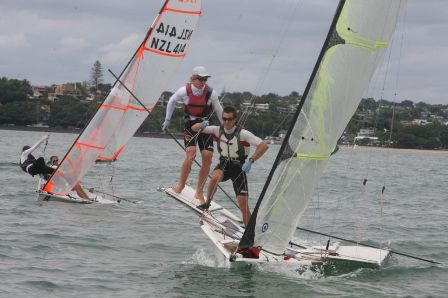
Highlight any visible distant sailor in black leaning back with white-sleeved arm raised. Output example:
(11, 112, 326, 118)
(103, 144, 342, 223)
(19, 135, 54, 179)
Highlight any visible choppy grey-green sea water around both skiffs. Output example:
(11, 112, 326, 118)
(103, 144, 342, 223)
(0, 130, 448, 297)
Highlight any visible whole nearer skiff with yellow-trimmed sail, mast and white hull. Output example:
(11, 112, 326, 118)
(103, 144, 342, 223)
(165, 0, 403, 266)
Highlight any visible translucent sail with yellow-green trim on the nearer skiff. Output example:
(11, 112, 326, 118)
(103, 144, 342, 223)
(242, 0, 403, 254)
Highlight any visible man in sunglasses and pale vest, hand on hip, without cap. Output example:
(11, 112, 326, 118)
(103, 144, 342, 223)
(192, 106, 269, 225)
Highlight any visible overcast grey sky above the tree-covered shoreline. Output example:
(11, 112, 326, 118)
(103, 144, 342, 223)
(0, 0, 448, 104)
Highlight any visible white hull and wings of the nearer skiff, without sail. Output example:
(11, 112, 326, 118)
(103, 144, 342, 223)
(160, 186, 390, 267)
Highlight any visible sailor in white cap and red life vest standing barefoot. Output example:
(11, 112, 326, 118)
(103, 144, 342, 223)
(162, 66, 222, 204)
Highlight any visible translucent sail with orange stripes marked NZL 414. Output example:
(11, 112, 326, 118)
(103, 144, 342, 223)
(44, 0, 201, 195)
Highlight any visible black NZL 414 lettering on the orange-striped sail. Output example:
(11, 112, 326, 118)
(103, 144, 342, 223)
(150, 22, 193, 54)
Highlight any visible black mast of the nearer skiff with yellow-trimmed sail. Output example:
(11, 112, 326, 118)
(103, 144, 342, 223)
(239, 0, 346, 248)
